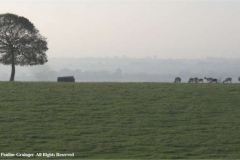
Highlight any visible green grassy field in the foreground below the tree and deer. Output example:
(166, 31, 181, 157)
(0, 82, 240, 159)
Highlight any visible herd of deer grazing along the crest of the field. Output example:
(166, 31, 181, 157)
(174, 77, 240, 83)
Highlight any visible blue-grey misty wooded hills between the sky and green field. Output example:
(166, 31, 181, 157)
(0, 57, 240, 82)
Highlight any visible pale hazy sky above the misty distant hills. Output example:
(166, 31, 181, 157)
(0, 0, 240, 58)
